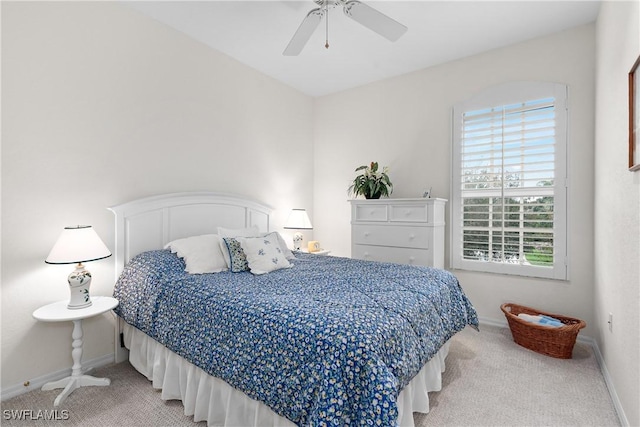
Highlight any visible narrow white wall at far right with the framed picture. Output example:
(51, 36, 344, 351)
(594, 0, 640, 426)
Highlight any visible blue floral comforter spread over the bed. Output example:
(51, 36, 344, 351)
(114, 250, 478, 426)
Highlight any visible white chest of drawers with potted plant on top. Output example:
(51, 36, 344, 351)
(350, 199, 447, 268)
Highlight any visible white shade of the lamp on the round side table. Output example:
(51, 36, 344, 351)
(45, 225, 111, 264)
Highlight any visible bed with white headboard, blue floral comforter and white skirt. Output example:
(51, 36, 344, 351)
(111, 193, 478, 426)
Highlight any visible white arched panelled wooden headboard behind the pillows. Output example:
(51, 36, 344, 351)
(109, 192, 271, 280)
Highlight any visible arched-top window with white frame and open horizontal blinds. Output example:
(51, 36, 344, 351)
(451, 83, 568, 280)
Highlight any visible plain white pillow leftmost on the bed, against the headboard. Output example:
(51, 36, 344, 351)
(165, 234, 228, 274)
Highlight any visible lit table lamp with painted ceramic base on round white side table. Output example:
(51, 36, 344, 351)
(44, 225, 111, 310)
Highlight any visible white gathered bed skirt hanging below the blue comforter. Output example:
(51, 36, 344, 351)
(123, 323, 449, 427)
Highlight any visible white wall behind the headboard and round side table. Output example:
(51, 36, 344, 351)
(1, 2, 313, 389)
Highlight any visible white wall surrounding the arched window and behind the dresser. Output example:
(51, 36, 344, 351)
(314, 24, 595, 334)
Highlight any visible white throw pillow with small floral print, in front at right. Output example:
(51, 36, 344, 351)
(236, 232, 291, 274)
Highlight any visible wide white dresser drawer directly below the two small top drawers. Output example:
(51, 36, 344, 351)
(351, 224, 433, 249)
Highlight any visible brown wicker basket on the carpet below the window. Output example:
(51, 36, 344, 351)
(500, 303, 587, 359)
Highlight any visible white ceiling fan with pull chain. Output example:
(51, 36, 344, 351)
(282, 0, 407, 56)
